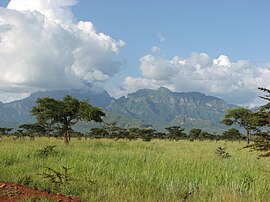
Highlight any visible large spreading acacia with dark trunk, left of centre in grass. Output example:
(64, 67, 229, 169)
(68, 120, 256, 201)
(31, 95, 105, 144)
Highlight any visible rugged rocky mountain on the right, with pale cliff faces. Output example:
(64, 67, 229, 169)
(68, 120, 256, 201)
(106, 87, 237, 130)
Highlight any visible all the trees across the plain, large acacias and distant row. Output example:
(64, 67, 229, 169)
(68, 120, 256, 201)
(0, 88, 270, 156)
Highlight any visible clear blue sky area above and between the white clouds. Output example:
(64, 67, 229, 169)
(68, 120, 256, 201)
(73, 0, 270, 62)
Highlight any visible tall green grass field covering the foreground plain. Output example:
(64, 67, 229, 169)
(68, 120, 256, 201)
(0, 137, 270, 202)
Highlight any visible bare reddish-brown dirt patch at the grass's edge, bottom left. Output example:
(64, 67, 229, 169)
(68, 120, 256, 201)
(0, 181, 81, 202)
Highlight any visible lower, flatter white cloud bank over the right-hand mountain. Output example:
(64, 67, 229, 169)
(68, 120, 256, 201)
(118, 51, 270, 104)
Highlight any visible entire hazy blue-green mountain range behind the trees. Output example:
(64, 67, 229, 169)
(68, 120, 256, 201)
(0, 87, 237, 131)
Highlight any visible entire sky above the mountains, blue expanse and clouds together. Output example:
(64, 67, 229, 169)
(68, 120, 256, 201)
(0, 0, 270, 106)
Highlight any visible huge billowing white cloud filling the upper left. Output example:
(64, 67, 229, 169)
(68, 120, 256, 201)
(0, 0, 125, 101)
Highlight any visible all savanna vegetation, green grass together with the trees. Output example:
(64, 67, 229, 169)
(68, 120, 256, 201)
(0, 88, 270, 201)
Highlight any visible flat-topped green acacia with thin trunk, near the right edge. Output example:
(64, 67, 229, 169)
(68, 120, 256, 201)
(221, 107, 263, 144)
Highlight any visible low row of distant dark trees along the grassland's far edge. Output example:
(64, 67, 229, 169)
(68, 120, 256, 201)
(0, 122, 244, 141)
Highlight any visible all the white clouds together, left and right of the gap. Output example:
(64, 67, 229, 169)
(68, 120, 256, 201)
(0, 0, 270, 104)
